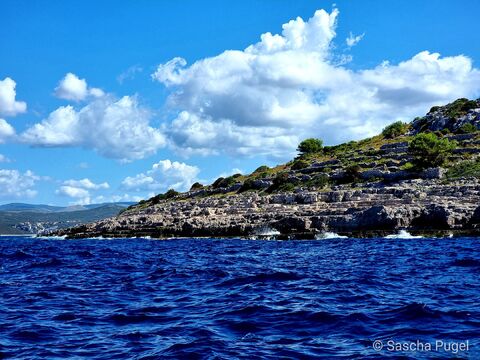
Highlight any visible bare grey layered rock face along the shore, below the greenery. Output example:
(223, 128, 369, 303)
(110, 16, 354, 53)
(53, 179, 480, 237)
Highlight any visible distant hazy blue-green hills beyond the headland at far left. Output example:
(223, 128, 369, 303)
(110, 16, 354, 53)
(0, 202, 134, 234)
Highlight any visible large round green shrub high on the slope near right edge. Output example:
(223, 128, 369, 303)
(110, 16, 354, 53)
(408, 133, 457, 169)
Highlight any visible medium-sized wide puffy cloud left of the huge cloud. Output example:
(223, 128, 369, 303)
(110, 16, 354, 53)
(20, 95, 165, 161)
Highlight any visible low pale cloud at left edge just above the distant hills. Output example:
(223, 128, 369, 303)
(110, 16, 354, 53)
(0, 169, 40, 199)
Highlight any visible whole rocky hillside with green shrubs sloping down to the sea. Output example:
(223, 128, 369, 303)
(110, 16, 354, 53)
(54, 99, 480, 237)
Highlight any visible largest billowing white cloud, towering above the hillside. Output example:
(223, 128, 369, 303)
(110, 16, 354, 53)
(152, 9, 480, 158)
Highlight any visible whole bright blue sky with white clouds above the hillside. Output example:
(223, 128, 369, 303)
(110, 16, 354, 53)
(0, 0, 480, 205)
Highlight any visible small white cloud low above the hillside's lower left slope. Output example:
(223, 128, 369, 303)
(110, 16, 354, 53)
(122, 159, 200, 192)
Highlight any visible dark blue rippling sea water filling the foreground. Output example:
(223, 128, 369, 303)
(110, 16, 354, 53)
(0, 237, 480, 359)
